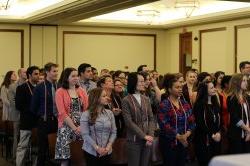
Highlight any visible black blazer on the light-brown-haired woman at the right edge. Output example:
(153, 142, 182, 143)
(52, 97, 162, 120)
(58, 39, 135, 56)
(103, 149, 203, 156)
(227, 96, 249, 141)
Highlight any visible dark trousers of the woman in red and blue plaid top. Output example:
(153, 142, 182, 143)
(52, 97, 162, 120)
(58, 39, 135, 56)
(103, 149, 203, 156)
(159, 137, 187, 166)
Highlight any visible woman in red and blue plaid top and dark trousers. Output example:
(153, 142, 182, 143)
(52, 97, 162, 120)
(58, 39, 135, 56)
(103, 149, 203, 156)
(158, 74, 195, 166)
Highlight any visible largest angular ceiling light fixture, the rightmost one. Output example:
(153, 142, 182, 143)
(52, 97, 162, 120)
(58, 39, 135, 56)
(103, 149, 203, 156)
(175, 0, 200, 18)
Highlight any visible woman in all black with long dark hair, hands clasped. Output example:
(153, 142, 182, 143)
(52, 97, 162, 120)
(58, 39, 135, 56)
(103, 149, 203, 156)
(193, 81, 221, 165)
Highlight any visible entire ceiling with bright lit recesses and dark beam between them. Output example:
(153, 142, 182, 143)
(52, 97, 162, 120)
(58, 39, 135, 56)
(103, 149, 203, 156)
(0, 0, 250, 28)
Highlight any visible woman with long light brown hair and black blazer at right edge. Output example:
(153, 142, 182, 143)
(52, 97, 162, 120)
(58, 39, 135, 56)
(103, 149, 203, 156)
(227, 74, 250, 154)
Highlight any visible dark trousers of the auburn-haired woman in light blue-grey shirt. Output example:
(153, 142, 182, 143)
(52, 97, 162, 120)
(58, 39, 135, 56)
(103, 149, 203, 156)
(84, 151, 111, 166)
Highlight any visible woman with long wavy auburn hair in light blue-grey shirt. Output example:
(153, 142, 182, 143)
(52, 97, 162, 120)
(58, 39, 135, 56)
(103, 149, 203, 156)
(81, 88, 116, 166)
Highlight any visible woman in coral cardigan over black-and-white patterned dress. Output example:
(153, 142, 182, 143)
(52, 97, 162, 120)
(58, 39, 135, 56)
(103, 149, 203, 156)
(55, 68, 88, 166)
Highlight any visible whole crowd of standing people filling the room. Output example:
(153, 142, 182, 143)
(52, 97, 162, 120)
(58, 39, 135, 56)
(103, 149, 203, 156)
(1, 61, 250, 166)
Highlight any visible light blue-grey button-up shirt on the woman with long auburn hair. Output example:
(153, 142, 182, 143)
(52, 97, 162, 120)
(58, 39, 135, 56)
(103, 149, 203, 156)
(80, 109, 116, 156)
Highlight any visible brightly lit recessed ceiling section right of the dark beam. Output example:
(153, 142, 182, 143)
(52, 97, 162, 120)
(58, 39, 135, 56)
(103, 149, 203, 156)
(76, 0, 250, 27)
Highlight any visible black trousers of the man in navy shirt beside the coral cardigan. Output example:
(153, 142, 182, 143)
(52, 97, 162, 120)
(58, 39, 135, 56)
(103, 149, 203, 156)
(37, 117, 58, 166)
